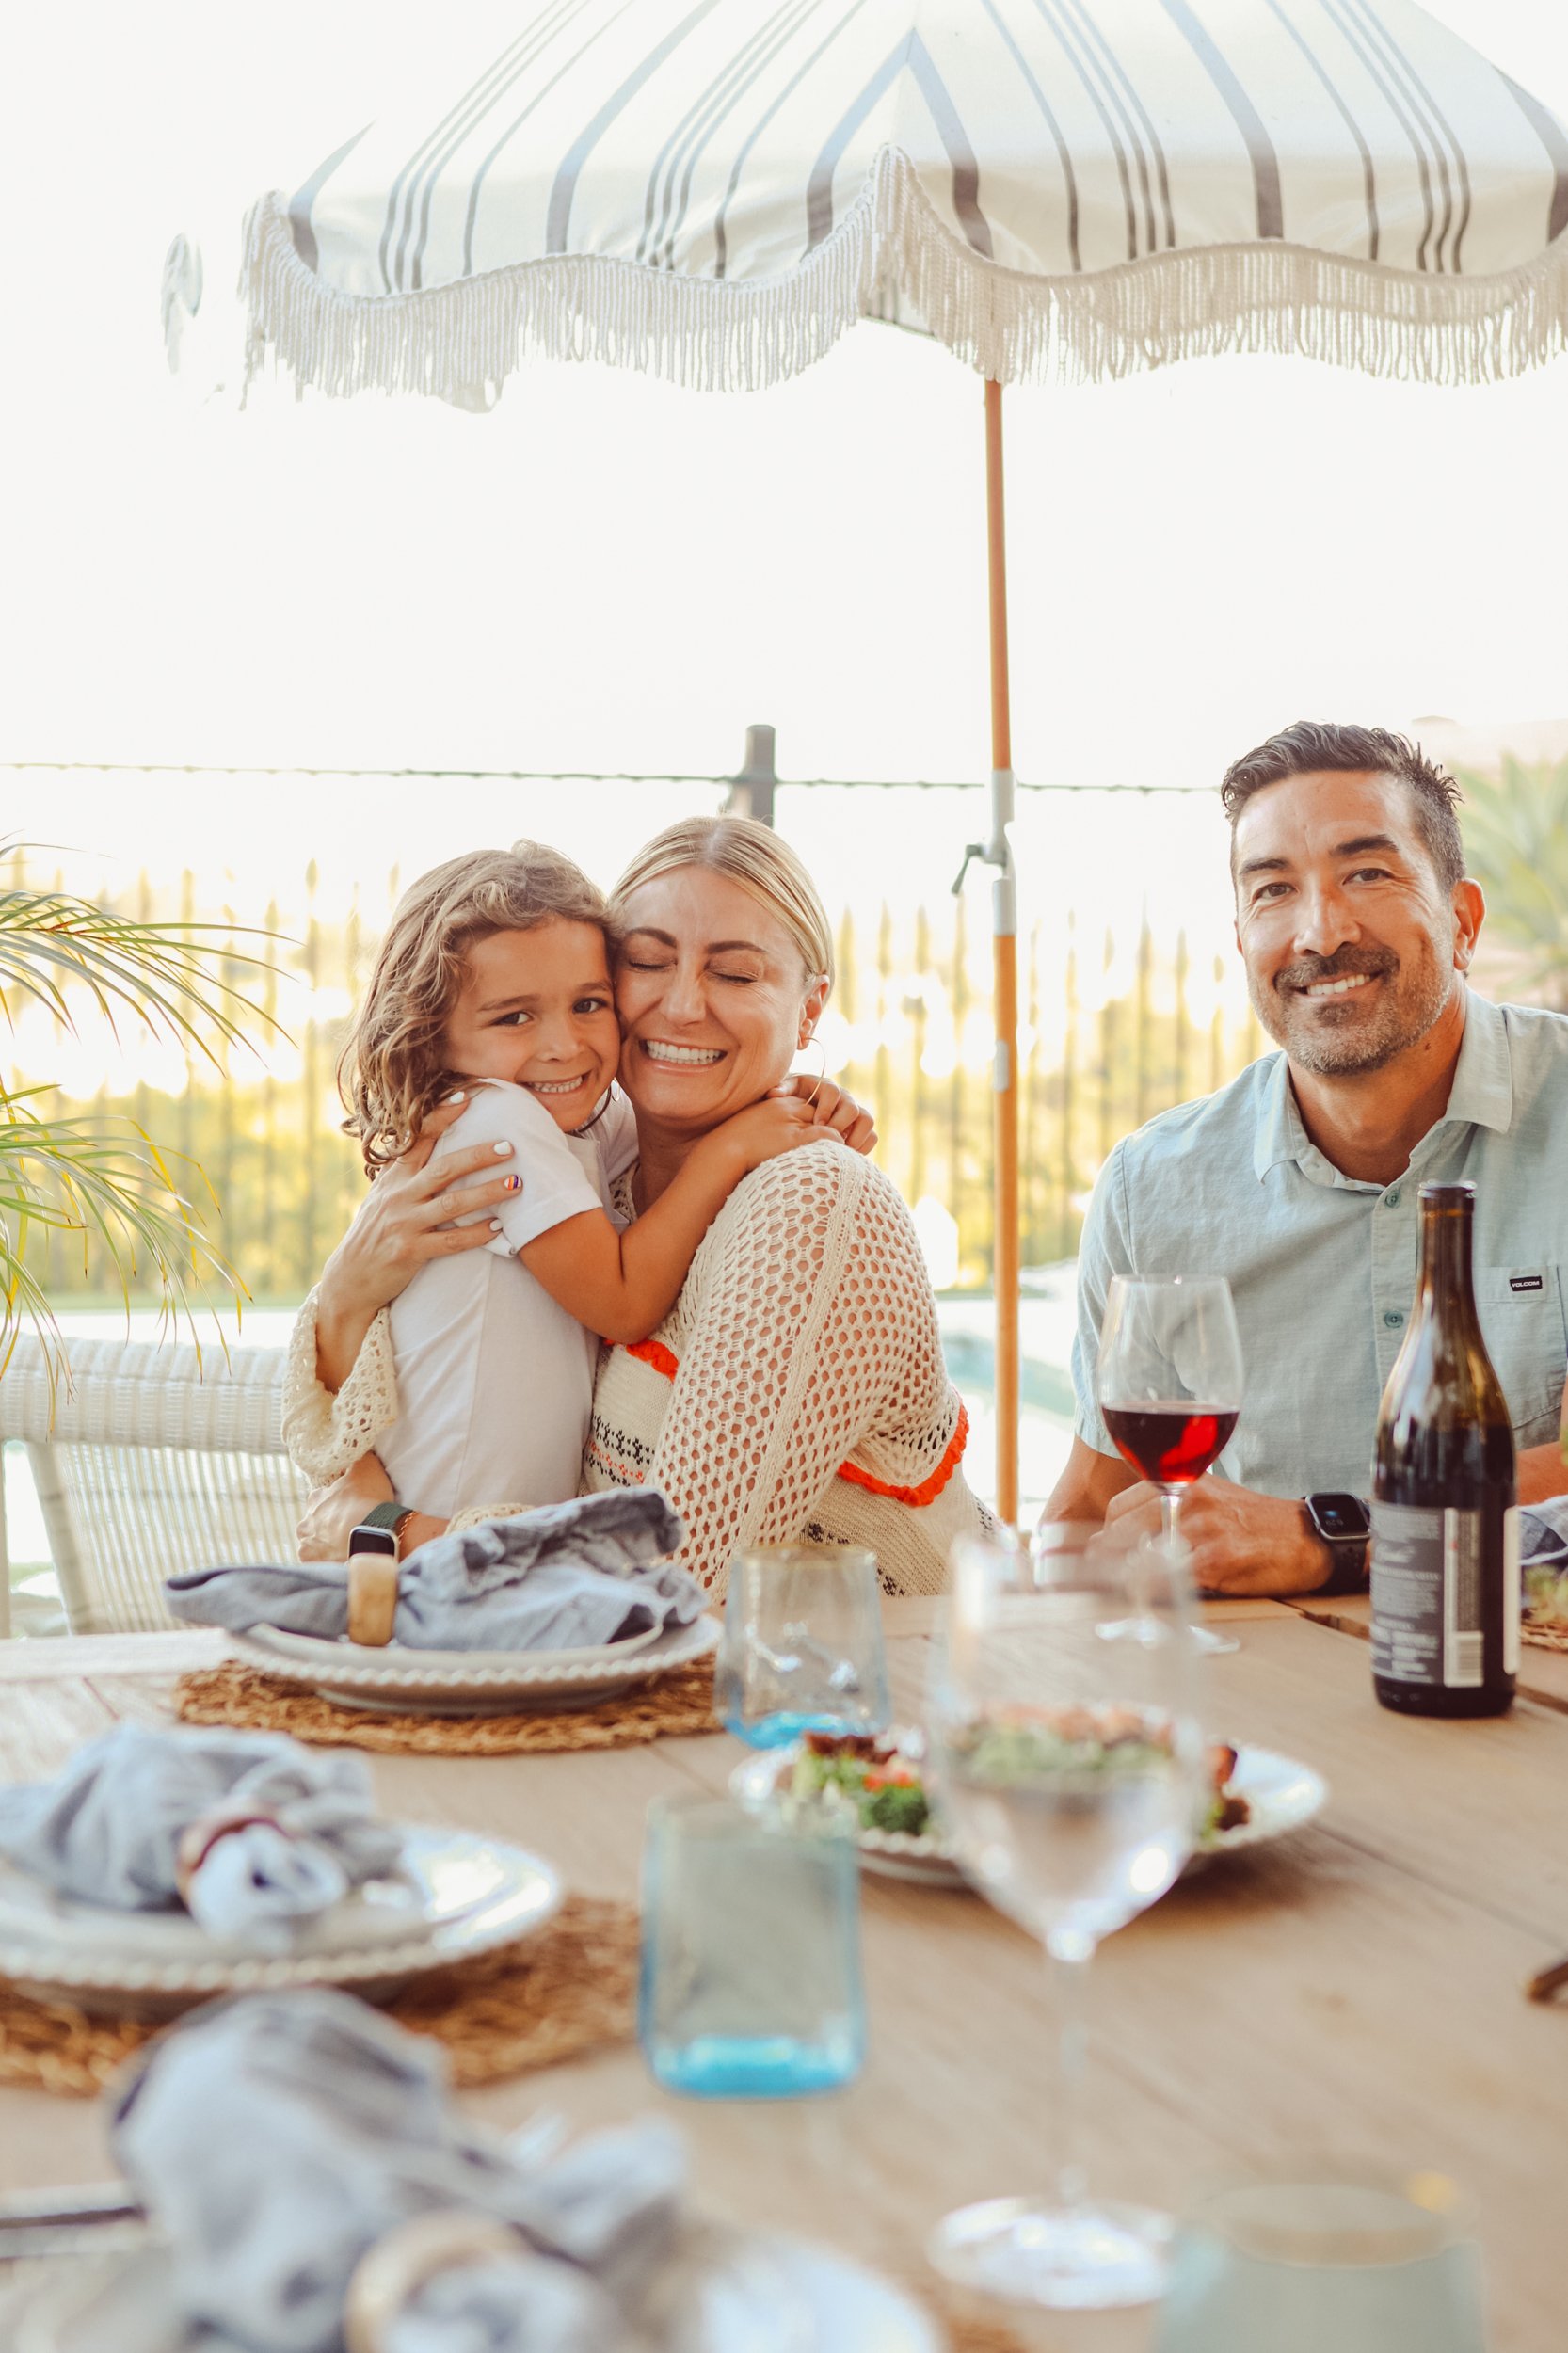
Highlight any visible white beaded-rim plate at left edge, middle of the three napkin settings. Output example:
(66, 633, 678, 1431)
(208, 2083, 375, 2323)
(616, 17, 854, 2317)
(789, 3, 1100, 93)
(0, 1824, 560, 2009)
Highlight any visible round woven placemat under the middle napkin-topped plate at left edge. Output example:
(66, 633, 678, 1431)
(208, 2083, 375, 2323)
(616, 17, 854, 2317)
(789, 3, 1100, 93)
(0, 1897, 638, 2097)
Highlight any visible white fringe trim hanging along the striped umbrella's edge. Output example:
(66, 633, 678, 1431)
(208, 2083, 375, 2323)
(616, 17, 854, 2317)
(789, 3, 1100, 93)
(240, 149, 1568, 408)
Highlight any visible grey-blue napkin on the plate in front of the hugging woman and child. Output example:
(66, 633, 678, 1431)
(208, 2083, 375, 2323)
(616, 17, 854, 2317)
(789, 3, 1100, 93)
(163, 1487, 706, 1650)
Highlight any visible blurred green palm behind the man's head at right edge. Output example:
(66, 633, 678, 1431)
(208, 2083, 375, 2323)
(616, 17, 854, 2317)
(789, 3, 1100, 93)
(1455, 753, 1568, 1012)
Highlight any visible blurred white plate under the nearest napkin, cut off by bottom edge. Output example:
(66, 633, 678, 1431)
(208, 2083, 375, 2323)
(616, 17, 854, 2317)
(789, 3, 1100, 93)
(12, 2233, 942, 2353)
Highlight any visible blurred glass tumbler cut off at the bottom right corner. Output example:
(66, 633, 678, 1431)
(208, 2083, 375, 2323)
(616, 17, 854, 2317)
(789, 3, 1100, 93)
(1156, 2168, 1485, 2353)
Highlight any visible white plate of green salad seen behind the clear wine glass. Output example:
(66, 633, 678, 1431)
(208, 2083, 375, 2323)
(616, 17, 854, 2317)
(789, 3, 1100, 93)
(729, 1725, 1328, 1887)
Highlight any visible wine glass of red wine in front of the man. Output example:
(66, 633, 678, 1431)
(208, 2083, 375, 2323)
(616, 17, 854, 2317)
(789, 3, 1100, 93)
(1095, 1275, 1240, 1652)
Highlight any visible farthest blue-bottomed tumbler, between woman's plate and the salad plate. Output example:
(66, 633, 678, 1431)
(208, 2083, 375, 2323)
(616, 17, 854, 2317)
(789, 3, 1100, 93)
(713, 1544, 892, 1749)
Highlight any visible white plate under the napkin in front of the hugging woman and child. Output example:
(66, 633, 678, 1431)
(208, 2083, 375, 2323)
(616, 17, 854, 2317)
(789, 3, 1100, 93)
(229, 1617, 718, 1716)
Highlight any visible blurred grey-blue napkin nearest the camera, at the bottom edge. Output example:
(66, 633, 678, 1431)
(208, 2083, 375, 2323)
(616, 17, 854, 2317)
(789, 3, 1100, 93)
(111, 1991, 685, 2353)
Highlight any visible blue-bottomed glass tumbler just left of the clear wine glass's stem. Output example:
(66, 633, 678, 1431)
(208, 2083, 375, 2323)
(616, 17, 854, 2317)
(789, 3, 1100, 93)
(638, 1796, 867, 2099)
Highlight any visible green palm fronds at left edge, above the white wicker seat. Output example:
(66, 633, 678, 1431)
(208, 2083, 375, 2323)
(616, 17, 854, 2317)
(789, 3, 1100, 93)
(0, 842, 278, 1372)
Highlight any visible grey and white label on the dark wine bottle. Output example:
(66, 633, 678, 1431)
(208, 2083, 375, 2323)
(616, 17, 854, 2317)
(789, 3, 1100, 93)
(1372, 1504, 1487, 1689)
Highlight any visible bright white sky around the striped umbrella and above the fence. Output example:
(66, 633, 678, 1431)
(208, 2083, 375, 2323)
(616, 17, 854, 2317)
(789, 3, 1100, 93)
(0, 0, 1568, 913)
